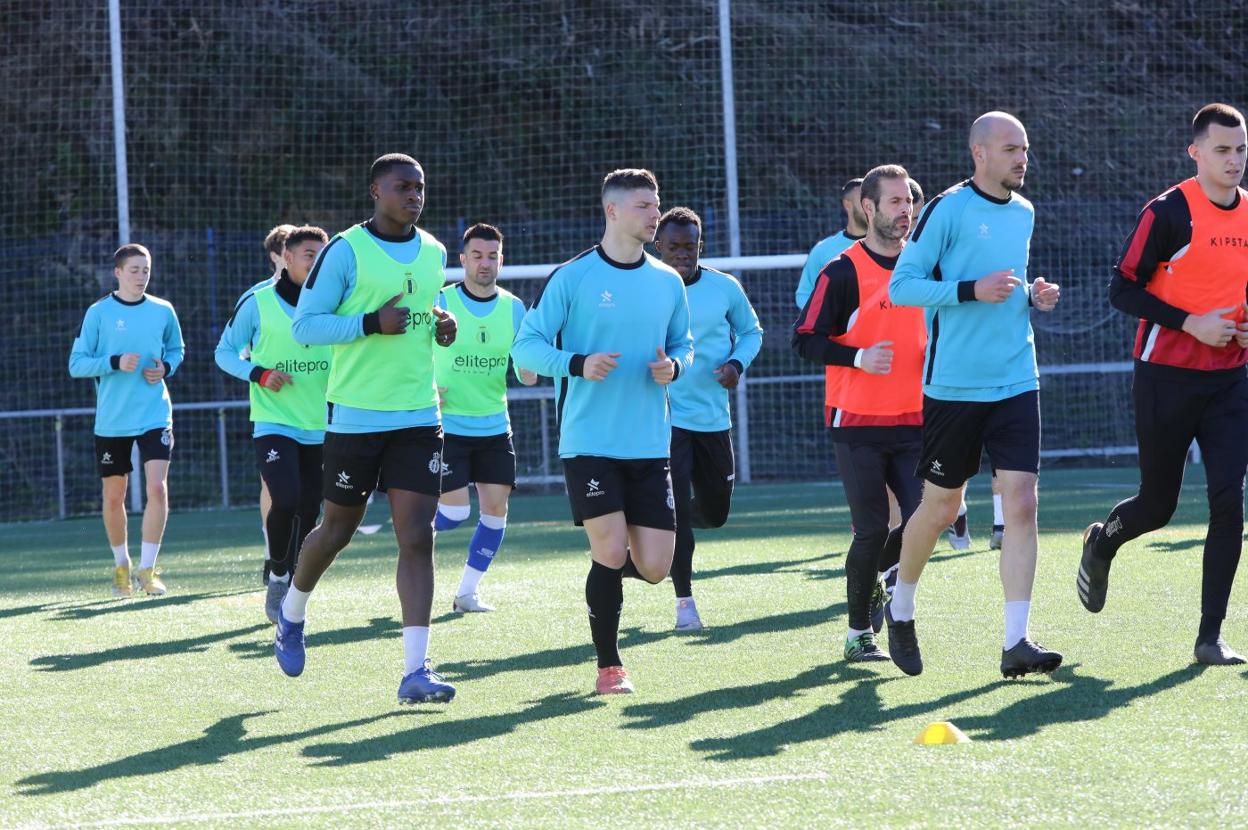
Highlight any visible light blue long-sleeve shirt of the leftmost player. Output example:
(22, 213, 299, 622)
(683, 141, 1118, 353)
(70, 293, 186, 438)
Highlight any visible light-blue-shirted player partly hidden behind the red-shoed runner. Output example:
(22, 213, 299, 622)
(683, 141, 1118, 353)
(654, 207, 763, 632)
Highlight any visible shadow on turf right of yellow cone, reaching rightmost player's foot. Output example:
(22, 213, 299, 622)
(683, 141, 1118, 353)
(957, 663, 1208, 740)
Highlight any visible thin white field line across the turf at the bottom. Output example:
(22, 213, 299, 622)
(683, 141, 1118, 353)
(19, 773, 830, 830)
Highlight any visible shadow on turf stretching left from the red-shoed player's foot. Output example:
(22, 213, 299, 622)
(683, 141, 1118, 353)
(303, 691, 607, 766)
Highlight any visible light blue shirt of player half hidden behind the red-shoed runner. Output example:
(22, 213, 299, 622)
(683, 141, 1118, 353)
(668, 266, 763, 432)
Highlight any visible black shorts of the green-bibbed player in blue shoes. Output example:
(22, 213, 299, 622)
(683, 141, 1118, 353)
(322, 427, 442, 507)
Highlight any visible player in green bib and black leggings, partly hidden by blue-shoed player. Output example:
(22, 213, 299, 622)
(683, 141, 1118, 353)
(216, 227, 331, 624)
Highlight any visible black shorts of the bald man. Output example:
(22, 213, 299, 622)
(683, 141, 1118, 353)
(915, 391, 1040, 489)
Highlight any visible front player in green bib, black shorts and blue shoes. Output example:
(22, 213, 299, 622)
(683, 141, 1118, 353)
(275, 154, 456, 703)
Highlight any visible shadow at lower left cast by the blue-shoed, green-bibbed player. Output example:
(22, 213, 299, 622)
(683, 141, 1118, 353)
(16, 710, 411, 795)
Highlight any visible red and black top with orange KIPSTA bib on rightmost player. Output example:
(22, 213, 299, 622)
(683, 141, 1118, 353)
(1109, 178, 1248, 372)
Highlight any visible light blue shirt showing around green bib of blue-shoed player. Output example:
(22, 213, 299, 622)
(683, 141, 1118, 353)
(291, 225, 447, 433)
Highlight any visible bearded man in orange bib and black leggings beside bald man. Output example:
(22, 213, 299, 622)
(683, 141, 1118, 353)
(792, 165, 927, 663)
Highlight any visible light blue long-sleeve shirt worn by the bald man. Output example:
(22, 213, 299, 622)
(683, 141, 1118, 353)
(889, 181, 1040, 401)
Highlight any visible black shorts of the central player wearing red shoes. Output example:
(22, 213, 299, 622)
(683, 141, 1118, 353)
(563, 456, 676, 530)
